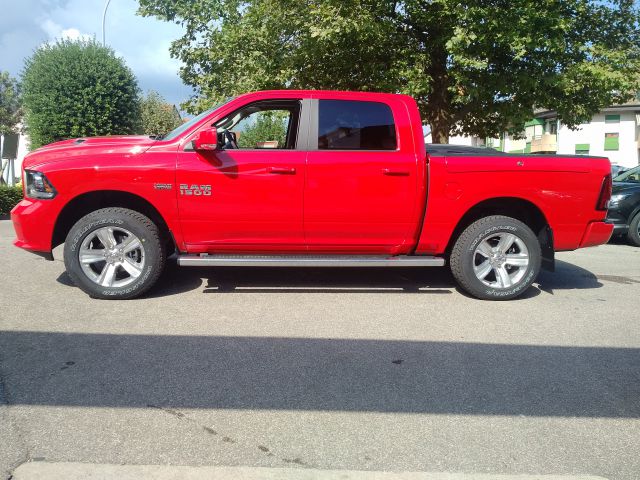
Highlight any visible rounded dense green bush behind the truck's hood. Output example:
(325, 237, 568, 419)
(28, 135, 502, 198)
(22, 40, 140, 148)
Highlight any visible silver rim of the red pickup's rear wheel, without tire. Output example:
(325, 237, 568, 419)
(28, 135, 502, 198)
(473, 232, 529, 288)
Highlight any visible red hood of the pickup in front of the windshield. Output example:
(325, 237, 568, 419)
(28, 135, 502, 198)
(23, 135, 156, 168)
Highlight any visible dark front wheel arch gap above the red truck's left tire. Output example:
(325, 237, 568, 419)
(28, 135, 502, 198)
(51, 190, 175, 253)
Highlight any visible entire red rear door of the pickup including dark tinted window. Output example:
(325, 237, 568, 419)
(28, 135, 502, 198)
(304, 98, 421, 253)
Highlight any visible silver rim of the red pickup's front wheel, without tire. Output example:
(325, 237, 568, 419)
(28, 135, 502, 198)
(78, 227, 145, 288)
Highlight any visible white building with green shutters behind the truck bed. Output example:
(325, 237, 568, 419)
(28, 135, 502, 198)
(425, 101, 640, 167)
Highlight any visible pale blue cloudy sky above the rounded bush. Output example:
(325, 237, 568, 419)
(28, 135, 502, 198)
(0, 0, 191, 106)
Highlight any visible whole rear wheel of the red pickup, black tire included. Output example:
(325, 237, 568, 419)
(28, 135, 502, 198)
(450, 215, 542, 300)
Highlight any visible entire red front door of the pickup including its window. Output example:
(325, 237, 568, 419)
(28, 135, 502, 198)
(176, 100, 306, 252)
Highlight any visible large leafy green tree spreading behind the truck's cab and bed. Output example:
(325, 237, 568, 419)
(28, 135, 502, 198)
(139, 0, 640, 143)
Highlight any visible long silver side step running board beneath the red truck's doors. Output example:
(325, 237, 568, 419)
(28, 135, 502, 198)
(178, 255, 445, 267)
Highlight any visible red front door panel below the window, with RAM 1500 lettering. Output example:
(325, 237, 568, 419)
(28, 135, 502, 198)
(176, 150, 307, 252)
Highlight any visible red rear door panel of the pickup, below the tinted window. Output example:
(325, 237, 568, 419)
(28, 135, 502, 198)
(304, 150, 417, 253)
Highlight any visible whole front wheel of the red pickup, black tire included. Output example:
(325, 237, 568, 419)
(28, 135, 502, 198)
(64, 208, 166, 300)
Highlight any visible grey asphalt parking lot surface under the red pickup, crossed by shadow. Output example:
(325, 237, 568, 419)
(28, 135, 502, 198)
(0, 221, 640, 479)
